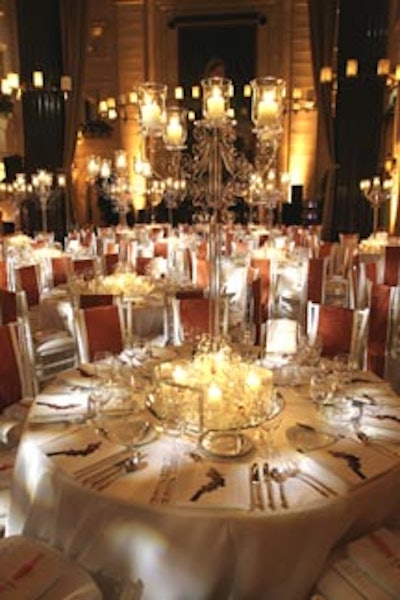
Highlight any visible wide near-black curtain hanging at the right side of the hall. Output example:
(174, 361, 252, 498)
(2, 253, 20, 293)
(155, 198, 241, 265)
(333, 0, 388, 237)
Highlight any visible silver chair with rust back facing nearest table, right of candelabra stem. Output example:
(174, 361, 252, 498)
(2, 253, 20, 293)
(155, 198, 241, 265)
(306, 302, 369, 368)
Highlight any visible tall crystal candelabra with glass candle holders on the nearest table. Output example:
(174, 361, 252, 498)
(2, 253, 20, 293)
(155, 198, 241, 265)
(138, 77, 285, 349)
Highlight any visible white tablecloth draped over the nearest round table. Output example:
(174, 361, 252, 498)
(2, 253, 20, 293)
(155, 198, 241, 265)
(7, 360, 400, 600)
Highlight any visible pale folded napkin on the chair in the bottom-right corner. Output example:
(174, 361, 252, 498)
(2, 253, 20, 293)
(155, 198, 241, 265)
(346, 528, 400, 598)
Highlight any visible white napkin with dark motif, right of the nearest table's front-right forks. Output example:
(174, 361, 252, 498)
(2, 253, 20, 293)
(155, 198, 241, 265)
(307, 438, 398, 490)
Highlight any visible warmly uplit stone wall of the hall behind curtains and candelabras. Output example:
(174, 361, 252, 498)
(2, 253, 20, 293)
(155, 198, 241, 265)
(0, 0, 400, 236)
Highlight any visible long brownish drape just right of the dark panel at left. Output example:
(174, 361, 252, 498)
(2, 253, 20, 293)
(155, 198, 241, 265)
(59, 0, 88, 226)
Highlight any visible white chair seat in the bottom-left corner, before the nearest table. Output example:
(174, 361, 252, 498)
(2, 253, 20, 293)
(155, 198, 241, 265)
(0, 534, 103, 600)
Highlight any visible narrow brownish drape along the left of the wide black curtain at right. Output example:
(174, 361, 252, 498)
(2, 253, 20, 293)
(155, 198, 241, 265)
(308, 0, 339, 240)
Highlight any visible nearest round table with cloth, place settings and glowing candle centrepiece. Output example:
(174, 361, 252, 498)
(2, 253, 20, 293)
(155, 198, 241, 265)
(5, 344, 400, 599)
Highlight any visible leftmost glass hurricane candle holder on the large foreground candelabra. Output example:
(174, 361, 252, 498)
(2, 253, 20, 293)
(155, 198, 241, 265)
(138, 82, 167, 136)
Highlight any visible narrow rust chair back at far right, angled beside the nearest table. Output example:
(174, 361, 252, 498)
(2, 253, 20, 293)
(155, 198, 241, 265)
(367, 283, 391, 377)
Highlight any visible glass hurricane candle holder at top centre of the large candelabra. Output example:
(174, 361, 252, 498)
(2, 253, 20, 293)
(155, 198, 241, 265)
(201, 77, 232, 125)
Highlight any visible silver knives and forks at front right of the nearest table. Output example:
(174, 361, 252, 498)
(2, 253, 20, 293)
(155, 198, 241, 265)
(249, 461, 338, 511)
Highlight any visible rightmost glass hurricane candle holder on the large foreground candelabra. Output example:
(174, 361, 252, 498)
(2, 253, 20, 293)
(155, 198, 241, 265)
(250, 77, 286, 135)
